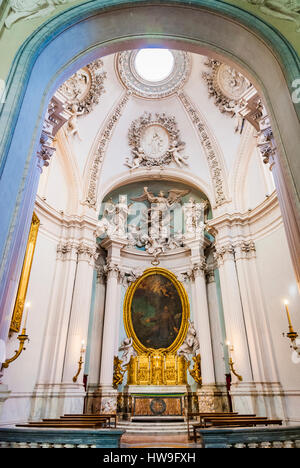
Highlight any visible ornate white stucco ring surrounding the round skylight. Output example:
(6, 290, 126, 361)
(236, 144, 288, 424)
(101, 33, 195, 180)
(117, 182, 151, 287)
(116, 50, 191, 99)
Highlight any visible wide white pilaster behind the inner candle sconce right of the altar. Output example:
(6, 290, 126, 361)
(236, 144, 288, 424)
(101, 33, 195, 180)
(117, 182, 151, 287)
(215, 244, 253, 383)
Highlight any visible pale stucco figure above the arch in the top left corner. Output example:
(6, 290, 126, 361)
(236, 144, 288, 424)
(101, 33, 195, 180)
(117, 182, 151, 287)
(5, 0, 68, 29)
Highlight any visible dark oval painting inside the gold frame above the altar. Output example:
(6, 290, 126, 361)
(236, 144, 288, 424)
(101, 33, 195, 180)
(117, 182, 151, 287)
(131, 274, 183, 349)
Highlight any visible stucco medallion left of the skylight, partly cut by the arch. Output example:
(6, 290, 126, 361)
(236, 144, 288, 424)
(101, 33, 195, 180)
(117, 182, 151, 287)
(58, 60, 106, 114)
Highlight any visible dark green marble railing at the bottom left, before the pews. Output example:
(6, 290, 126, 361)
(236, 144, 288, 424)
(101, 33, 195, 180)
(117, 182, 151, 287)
(0, 428, 124, 448)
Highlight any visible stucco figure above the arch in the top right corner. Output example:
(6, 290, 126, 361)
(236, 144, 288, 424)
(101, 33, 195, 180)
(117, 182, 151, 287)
(247, 0, 300, 32)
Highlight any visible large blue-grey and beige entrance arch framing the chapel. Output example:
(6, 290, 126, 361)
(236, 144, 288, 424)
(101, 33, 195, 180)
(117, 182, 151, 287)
(0, 0, 300, 344)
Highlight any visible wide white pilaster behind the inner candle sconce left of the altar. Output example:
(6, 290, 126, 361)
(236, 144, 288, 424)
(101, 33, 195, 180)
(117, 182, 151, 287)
(63, 242, 96, 383)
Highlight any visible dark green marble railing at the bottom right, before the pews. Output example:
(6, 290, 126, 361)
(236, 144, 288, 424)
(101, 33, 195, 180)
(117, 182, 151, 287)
(197, 426, 300, 448)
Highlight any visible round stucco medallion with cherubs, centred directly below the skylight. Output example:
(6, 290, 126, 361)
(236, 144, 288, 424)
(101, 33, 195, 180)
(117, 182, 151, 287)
(125, 112, 188, 169)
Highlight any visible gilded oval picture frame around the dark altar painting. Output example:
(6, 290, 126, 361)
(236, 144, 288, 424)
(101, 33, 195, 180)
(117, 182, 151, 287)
(123, 267, 190, 354)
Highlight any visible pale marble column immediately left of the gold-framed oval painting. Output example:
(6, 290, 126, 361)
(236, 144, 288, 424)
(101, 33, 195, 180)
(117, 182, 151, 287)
(100, 238, 126, 412)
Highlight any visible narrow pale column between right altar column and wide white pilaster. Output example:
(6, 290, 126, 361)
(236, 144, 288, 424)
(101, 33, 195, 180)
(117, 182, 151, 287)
(206, 267, 226, 385)
